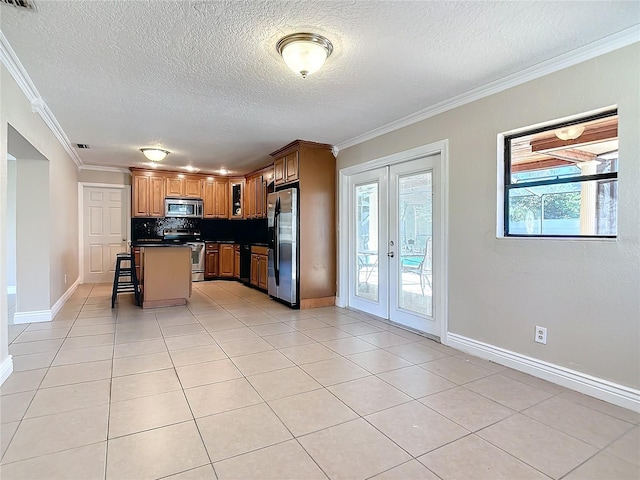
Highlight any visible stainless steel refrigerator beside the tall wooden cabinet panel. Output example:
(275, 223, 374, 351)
(267, 188, 298, 307)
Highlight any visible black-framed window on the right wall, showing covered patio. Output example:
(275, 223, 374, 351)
(504, 110, 618, 238)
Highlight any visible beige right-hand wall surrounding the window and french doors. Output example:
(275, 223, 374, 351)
(338, 43, 640, 388)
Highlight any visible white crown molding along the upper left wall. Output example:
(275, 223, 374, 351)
(0, 30, 82, 168)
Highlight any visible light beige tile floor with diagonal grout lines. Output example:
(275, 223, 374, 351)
(0, 282, 640, 480)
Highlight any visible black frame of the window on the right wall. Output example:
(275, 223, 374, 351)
(502, 108, 619, 239)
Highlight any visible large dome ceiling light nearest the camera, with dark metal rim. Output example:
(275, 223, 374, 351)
(276, 33, 333, 78)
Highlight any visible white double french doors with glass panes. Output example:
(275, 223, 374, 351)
(349, 155, 441, 337)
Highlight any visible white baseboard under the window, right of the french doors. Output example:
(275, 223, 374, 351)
(447, 333, 640, 412)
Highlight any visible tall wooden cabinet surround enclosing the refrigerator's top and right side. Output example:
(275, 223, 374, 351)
(271, 140, 336, 308)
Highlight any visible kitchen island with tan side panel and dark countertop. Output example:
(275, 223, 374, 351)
(134, 245, 191, 308)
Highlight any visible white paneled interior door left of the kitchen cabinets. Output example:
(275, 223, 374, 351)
(83, 186, 127, 283)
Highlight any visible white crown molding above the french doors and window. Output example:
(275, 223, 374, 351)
(336, 25, 640, 150)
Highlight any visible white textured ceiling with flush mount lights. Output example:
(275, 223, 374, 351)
(0, 0, 640, 173)
